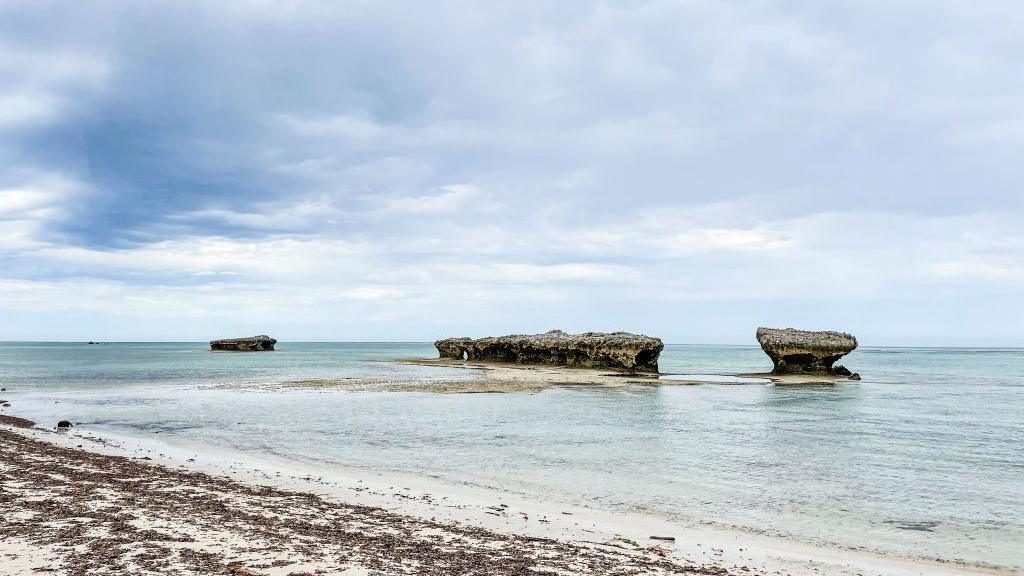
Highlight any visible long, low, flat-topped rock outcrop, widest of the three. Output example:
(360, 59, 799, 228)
(434, 330, 665, 372)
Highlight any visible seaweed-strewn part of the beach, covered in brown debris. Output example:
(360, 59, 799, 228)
(0, 416, 704, 575)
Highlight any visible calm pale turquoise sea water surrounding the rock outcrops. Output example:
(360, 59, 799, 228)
(0, 342, 1024, 569)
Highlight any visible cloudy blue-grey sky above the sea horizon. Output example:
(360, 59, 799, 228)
(0, 0, 1024, 346)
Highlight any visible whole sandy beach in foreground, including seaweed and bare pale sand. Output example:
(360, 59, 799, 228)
(0, 418, 1011, 576)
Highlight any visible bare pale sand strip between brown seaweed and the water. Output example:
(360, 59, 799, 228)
(0, 416, 1020, 576)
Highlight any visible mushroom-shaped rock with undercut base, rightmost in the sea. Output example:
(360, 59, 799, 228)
(757, 328, 857, 375)
